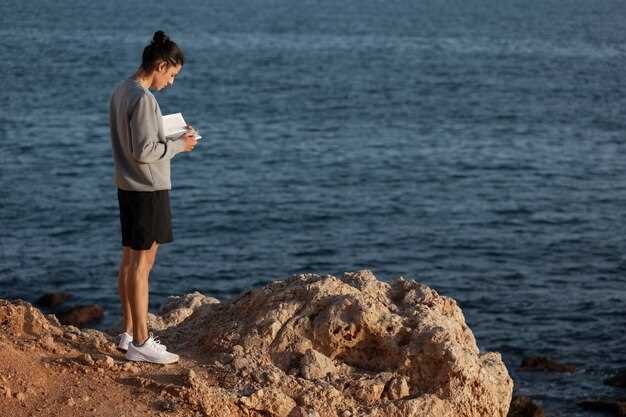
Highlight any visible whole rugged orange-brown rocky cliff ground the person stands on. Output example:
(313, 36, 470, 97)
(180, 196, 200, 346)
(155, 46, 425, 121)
(0, 271, 513, 417)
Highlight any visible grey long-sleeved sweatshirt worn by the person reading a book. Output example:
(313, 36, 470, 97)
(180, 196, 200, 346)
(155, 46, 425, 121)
(109, 78, 184, 191)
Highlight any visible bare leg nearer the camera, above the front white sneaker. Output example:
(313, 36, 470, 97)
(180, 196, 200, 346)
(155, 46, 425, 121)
(126, 242, 158, 344)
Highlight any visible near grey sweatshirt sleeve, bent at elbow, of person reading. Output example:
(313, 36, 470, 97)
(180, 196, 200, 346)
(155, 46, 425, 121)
(130, 94, 184, 164)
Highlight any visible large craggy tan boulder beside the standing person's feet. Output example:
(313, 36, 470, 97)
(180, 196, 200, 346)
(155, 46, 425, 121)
(172, 271, 513, 417)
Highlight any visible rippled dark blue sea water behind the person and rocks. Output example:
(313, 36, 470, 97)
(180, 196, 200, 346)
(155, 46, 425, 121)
(0, 0, 626, 416)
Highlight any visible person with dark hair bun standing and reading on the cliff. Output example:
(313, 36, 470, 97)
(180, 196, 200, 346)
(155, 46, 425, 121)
(109, 31, 197, 363)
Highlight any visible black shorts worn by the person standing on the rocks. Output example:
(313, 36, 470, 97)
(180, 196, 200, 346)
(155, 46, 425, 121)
(117, 188, 174, 250)
